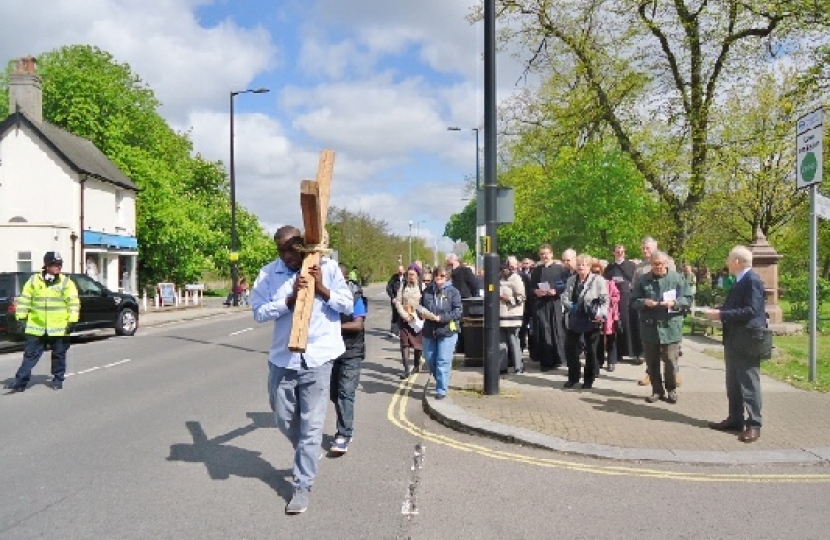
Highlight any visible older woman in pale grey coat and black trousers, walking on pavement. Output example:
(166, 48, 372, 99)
(562, 254, 608, 389)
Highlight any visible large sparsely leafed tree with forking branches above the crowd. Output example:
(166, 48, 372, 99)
(484, 0, 827, 254)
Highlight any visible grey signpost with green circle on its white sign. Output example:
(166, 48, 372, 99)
(795, 107, 830, 382)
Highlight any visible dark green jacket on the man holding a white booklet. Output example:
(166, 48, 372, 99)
(631, 270, 692, 345)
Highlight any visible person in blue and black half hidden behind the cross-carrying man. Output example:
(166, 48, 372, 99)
(331, 264, 366, 454)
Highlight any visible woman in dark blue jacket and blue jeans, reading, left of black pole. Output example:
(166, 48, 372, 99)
(418, 268, 461, 399)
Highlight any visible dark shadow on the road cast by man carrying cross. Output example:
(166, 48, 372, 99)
(167, 412, 294, 501)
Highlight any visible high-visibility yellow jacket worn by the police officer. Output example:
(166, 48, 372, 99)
(15, 273, 81, 336)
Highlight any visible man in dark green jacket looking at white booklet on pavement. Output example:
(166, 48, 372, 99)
(631, 251, 692, 403)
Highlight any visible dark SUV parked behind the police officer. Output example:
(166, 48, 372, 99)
(0, 272, 138, 341)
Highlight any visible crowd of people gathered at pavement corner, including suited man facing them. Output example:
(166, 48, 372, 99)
(386, 237, 766, 442)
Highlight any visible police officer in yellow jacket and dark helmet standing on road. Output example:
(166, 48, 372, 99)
(10, 251, 81, 392)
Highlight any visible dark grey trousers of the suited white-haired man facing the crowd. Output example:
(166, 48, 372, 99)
(723, 342, 761, 429)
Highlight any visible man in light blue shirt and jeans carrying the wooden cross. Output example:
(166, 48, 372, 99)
(251, 226, 354, 514)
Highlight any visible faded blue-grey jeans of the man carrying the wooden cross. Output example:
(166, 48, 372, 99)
(268, 362, 332, 489)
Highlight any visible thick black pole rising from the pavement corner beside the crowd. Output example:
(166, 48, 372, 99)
(484, 0, 499, 396)
